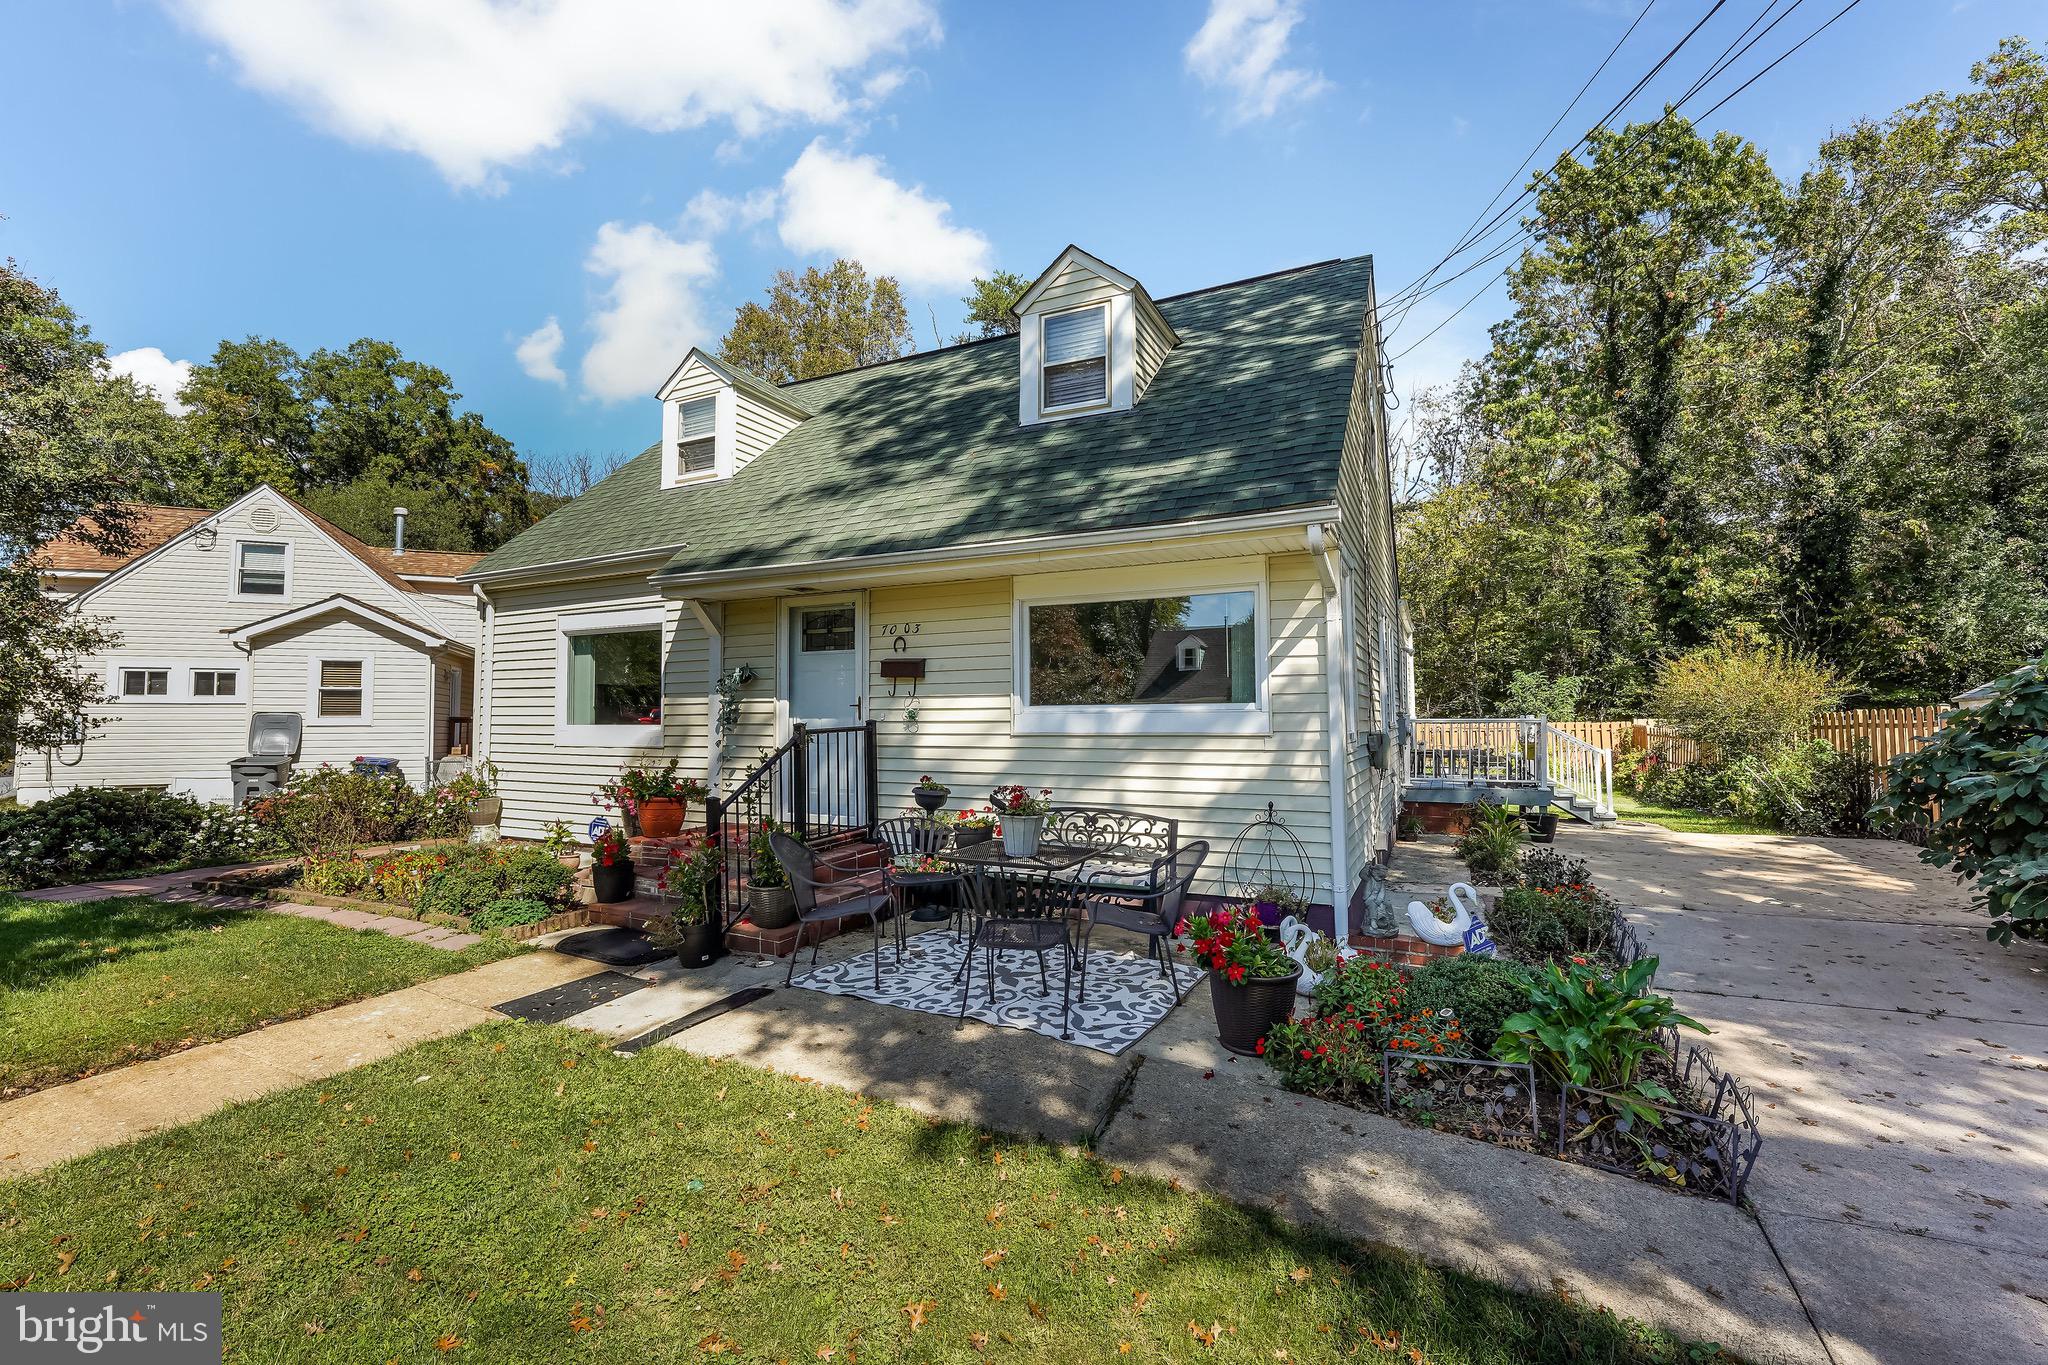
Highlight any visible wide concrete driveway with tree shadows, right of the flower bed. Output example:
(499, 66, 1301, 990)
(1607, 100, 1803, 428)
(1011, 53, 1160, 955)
(1559, 825, 2048, 1365)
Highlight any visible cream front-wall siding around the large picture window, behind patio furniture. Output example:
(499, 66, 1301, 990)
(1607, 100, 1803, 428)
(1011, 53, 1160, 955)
(868, 555, 1329, 900)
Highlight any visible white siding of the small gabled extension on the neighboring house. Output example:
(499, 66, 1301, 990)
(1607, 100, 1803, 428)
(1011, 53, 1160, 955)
(249, 616, 434, 786)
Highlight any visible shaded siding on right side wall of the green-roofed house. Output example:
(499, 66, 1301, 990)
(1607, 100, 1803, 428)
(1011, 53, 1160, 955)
(1337, 286, 1407, 886)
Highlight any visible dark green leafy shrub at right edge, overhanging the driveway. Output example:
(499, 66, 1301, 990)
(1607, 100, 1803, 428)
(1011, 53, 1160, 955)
(1876, 657, 2048, 943)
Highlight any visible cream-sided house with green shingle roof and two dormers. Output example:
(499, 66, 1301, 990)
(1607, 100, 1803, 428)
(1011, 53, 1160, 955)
(465, 248, 1409, 941)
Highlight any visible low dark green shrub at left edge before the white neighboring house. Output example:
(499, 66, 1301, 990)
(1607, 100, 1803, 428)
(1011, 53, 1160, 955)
(0, 786, 274, 888)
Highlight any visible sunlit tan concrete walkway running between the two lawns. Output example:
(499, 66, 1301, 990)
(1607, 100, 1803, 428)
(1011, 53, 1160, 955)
(0, 949, 604, 1181)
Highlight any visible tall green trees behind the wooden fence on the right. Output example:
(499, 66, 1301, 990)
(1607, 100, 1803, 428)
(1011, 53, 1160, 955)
(1403, 39, 2048, 714)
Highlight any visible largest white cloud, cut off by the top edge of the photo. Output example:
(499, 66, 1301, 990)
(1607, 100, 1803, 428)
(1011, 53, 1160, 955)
(164, 0, 940, 188)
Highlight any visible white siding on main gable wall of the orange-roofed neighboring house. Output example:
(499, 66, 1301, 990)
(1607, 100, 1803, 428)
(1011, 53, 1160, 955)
(16, 491, 438, 792)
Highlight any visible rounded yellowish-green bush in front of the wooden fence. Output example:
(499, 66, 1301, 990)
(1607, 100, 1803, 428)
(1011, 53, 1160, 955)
(1651, 641, 1843, 763)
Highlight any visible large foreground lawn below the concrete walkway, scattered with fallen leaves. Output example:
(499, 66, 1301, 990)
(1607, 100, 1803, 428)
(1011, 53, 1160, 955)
(0, 1023, 1710, 1365)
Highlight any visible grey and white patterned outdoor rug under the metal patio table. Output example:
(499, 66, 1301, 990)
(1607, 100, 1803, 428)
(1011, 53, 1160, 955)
(797, 931, 1202, 1056)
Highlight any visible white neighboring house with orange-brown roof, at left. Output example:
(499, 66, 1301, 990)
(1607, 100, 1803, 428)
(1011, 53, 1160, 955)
(16, 487, 481, 802)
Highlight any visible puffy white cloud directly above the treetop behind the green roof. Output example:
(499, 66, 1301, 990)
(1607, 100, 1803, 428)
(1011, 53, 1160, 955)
(778, 141, 991, 289)
